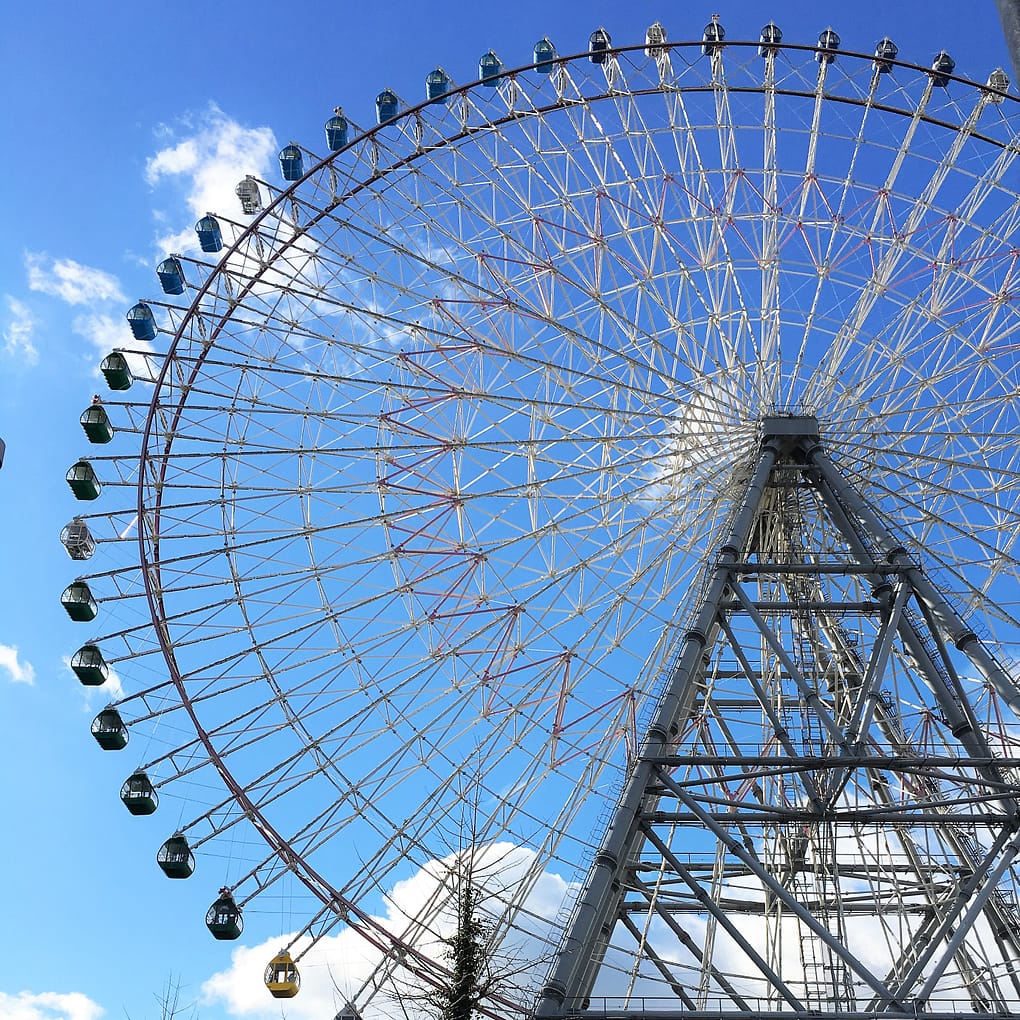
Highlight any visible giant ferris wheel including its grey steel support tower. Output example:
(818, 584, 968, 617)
(62, 20, 1020, 1017)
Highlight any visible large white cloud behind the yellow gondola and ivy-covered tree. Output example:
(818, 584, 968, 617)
(202, 844, 567, 1020)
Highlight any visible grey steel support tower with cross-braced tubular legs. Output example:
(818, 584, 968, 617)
(537, 416, 1020, 1017)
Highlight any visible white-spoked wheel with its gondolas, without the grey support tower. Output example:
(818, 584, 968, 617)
(62, 20, 1020, 1016)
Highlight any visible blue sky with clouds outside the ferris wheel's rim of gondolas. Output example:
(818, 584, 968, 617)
(0, 0, 1009, 1020)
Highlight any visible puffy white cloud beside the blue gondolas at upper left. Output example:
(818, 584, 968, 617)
(145, 104, 278, 252)
